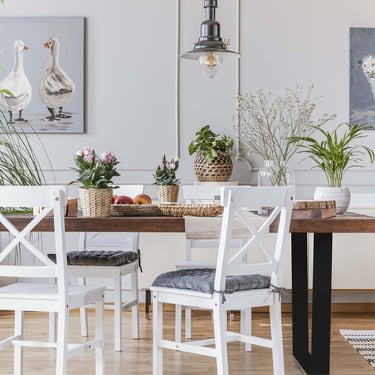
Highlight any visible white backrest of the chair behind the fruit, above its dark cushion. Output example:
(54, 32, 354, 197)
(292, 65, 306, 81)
(78, 185, 144, 252)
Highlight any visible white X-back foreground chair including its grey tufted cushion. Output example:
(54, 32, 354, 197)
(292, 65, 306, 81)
(151, 186, 293, 375)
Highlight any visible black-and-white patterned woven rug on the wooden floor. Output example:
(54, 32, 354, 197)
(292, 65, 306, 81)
(340, 329, 375, 369)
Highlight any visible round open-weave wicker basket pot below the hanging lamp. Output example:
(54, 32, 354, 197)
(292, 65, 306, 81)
(194, 151, 233, 182)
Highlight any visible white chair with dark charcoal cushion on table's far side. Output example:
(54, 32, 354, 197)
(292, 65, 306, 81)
(68, 185, 144, 351)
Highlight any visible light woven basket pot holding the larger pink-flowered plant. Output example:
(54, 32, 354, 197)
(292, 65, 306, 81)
(79, 188, 112, 217)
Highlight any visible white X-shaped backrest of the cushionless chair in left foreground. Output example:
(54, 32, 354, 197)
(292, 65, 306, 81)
(0, 186, 67, 298)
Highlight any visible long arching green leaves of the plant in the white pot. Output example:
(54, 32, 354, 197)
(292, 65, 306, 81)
(291, 123, 375, 187)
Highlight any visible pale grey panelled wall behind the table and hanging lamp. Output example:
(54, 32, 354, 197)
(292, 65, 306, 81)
(0, 0, 375, 288)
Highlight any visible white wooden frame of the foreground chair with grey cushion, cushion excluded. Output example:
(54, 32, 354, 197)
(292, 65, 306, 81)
(151, 187, 293, 375)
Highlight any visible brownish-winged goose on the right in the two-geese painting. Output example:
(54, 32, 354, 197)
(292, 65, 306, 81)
(39, 37, 75, 121)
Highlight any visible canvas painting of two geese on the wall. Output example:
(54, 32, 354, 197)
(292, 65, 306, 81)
(0, 17, 85, 134)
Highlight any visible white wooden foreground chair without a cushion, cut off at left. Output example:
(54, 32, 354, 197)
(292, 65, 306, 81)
(0, 186, 105, 375)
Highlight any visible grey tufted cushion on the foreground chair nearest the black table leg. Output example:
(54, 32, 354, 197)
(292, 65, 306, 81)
(152, 268, 270, 294)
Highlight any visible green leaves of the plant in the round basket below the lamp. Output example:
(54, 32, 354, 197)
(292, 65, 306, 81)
(188, 125, 234, 163)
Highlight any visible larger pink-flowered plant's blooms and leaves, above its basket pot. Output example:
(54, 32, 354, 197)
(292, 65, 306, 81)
(71, 147, 120, 189)
